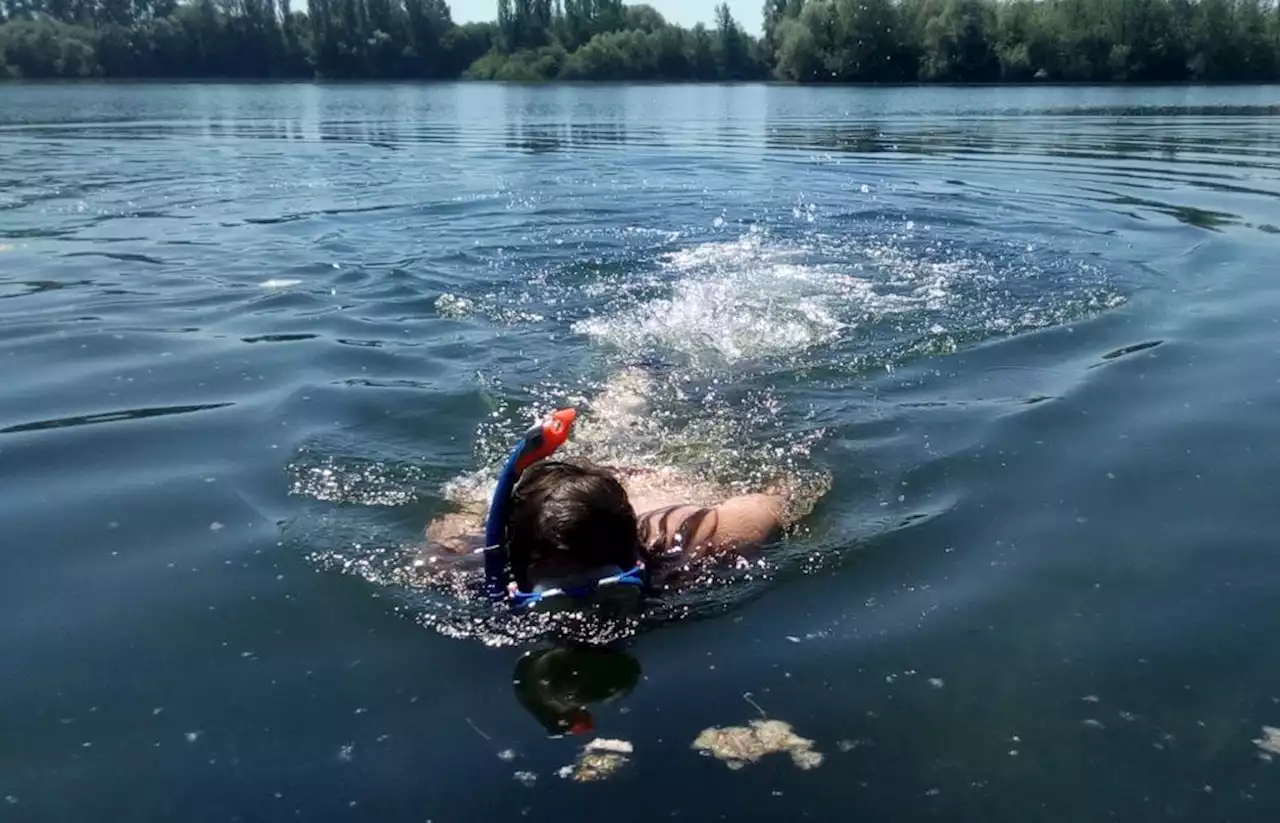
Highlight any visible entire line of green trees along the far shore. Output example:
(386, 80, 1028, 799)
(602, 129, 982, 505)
(0, 0, 1280, 83)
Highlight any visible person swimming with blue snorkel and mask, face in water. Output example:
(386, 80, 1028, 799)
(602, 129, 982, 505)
(426, 410, 786, 607)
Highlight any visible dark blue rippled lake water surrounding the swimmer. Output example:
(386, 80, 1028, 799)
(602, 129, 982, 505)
(0, 84, 1280, 822)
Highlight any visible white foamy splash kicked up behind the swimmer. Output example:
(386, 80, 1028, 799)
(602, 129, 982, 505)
(571, 223, 1123, 372)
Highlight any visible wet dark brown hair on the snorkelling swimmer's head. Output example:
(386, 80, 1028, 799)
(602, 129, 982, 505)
(507, 461, 640, 591)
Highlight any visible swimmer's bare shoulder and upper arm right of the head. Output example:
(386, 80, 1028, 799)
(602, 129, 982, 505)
(637, 494, 786, 554)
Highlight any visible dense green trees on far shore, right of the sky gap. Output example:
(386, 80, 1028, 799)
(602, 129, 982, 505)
(760, 0, 1280, 83)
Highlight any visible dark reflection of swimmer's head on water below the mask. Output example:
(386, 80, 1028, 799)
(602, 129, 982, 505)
(512, 645, 640, 737)
